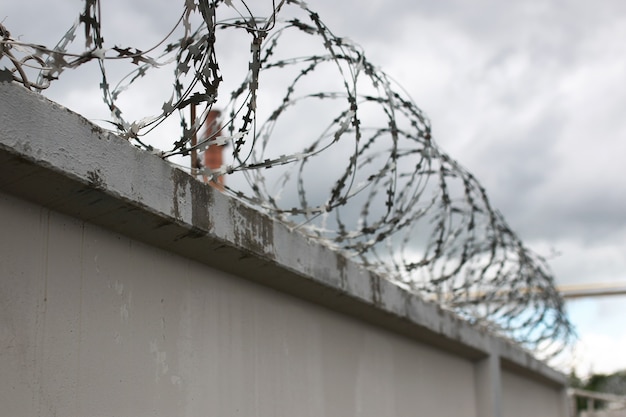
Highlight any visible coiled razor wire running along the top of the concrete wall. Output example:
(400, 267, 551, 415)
(0, 0, 573, 355)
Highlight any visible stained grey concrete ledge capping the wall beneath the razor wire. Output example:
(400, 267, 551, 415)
(0, 83, 565, 384)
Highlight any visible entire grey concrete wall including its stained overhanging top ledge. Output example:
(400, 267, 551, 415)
(0, 83, 566, 417)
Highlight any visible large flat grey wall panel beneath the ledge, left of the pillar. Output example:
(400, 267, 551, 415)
(0, 194, 477, 417)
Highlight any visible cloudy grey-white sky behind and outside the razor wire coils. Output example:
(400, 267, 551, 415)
(0, 0, 626, 374)
